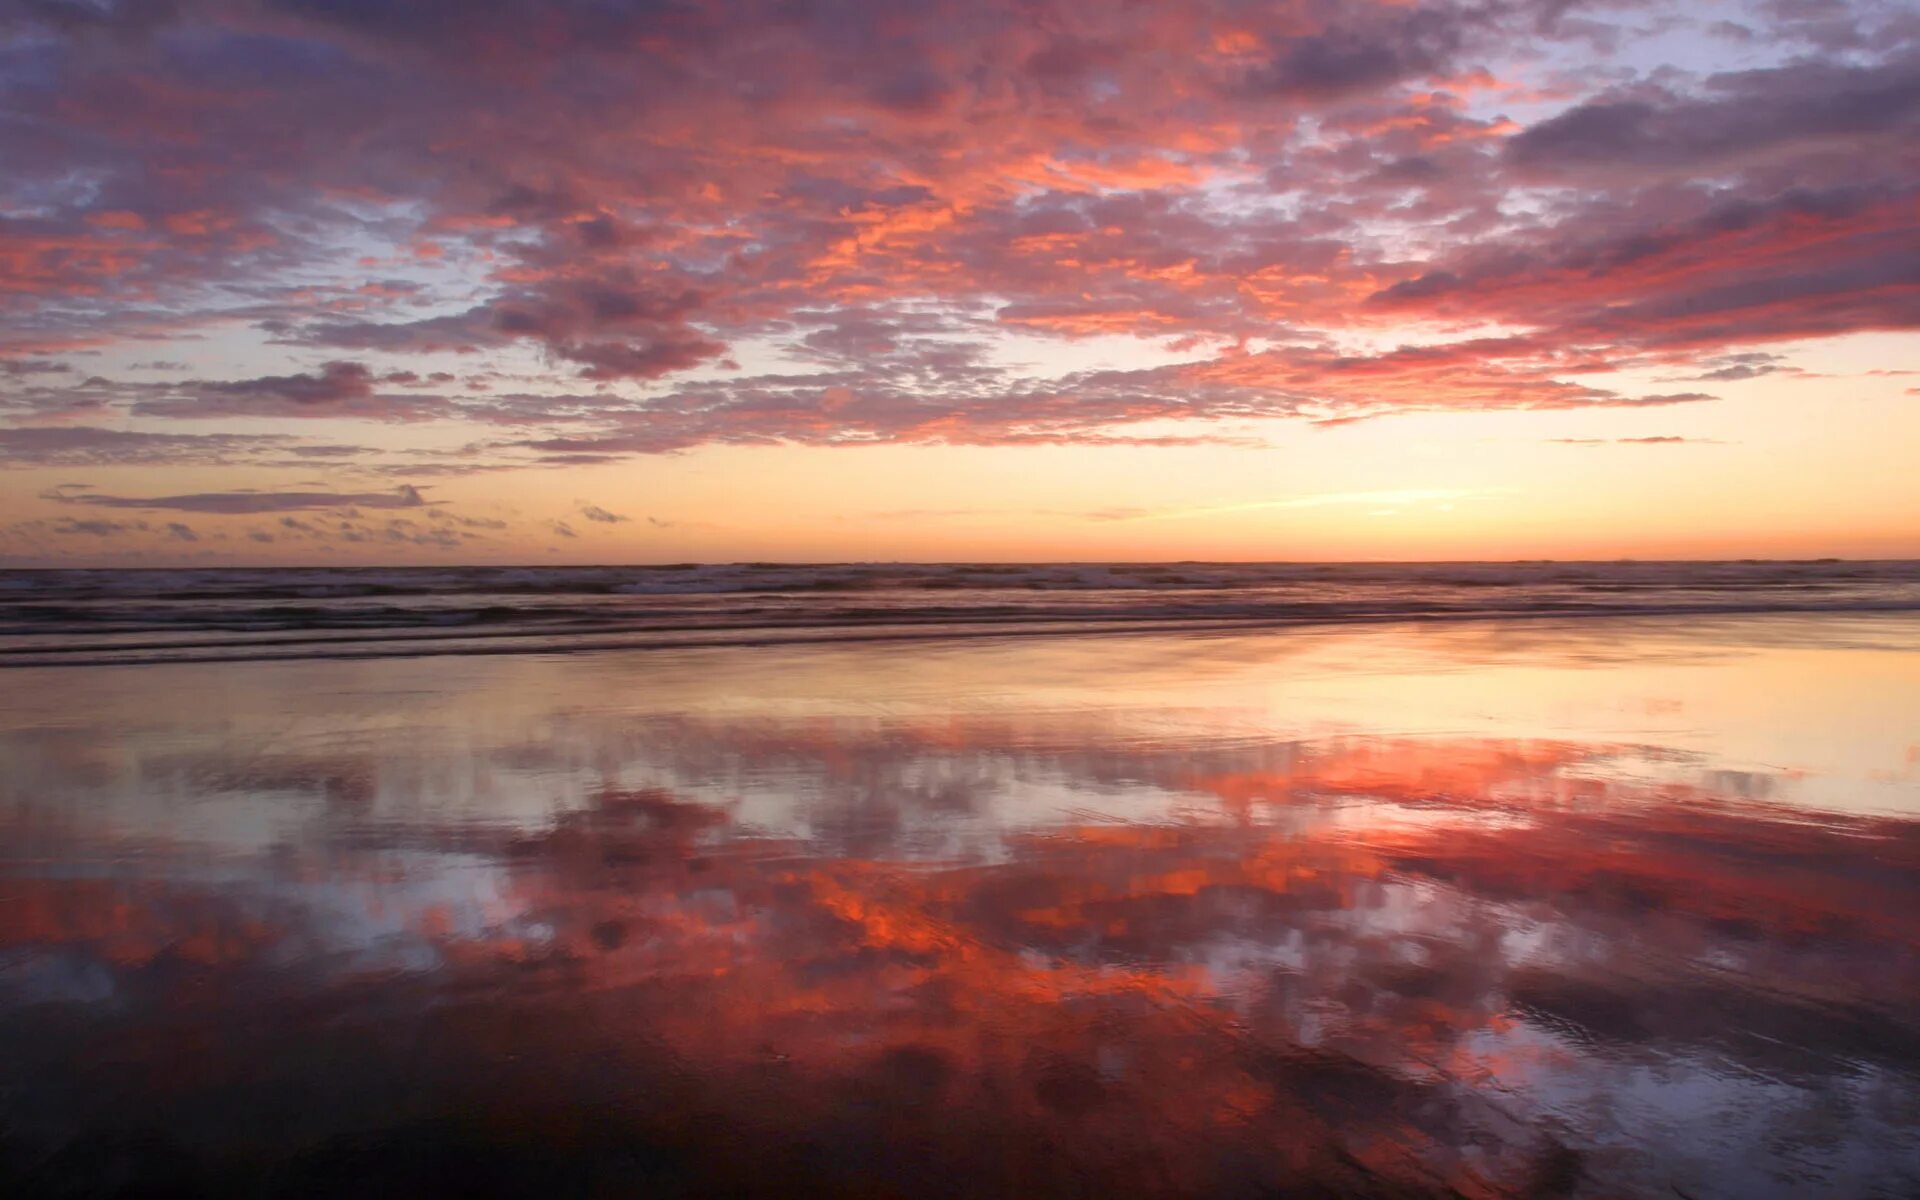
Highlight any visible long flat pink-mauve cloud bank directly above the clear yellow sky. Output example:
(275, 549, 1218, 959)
(493, 342, 1713, 463)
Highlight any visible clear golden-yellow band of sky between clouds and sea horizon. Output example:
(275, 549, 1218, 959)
(8, 338, 1920, 563)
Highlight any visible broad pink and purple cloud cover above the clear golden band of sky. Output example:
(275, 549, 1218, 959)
(0, 0, 1920, 491)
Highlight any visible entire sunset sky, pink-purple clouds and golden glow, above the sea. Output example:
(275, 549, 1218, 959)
(0, 0, 1920, 566)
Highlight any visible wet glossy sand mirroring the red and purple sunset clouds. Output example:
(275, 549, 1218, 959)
(0, 616, 1920, 1196)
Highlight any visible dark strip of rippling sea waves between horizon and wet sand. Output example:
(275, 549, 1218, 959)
(0, 559, 1920, 666)
